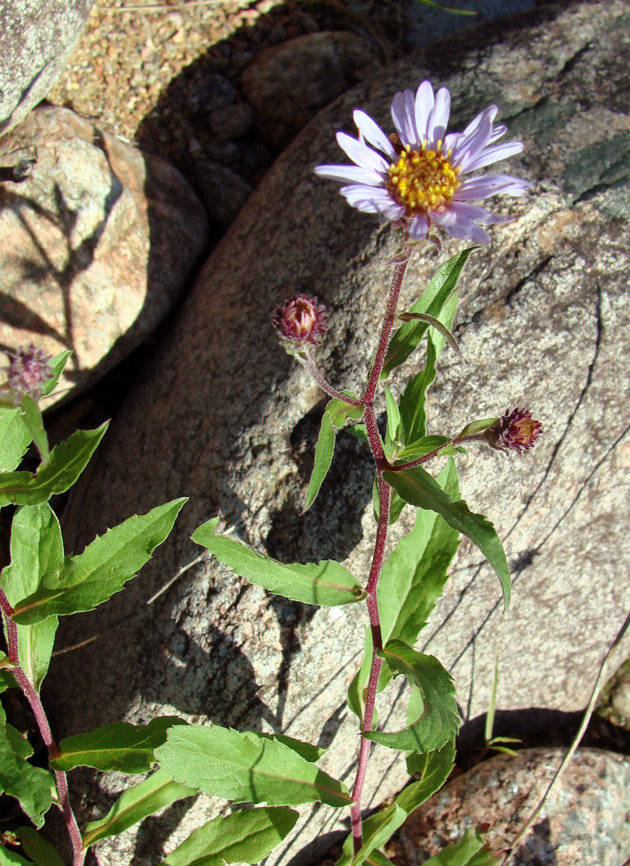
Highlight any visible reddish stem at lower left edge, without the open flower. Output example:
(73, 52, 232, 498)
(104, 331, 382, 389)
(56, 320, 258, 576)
(0, 589, 86, 866)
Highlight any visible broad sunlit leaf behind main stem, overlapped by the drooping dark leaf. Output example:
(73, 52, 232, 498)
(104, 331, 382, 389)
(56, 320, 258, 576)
(377, 460, 459, 646)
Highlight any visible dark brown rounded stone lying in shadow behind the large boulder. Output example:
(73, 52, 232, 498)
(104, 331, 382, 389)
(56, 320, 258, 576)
(242, 32, 378, 148)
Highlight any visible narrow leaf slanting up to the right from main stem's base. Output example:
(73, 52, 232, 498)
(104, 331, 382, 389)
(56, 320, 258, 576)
(336, 741, 455, 866)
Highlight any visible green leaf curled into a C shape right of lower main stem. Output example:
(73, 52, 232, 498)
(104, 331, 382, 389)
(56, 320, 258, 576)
(363, 640, 459, 752)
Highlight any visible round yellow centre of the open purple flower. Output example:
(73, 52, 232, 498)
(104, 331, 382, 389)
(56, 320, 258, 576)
(387, 141, 460, 216)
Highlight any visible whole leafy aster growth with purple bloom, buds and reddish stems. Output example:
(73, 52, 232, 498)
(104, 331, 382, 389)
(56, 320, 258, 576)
(0, 81, 541, 866)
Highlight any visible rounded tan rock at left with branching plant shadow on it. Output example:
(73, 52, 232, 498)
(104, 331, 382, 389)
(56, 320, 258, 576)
(0, 107, 207, 402)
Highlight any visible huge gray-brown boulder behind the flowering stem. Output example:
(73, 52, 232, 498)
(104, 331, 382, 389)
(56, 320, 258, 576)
(51, 0, 630, 864)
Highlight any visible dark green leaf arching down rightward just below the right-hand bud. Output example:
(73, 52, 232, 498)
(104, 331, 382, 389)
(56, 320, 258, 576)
(384, 466, 512, 610)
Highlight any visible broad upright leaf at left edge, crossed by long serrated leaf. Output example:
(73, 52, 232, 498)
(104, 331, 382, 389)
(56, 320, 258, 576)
(0, 503, 63, 692)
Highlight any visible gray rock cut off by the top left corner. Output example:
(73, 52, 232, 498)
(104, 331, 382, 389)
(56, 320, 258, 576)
(0, 0, 94, 135)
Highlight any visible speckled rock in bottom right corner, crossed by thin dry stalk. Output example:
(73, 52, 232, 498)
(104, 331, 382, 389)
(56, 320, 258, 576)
(389, 749, 630, 866)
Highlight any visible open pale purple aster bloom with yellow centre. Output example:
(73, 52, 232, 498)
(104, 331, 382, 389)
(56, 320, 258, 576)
(315, 81, 530, 243)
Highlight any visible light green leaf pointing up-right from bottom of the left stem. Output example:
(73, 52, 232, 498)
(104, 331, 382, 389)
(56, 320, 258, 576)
(83, 770, 197, 848)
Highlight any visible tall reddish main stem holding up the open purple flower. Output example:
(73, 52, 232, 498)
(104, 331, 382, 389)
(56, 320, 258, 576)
(350, 250, 411, 854)
